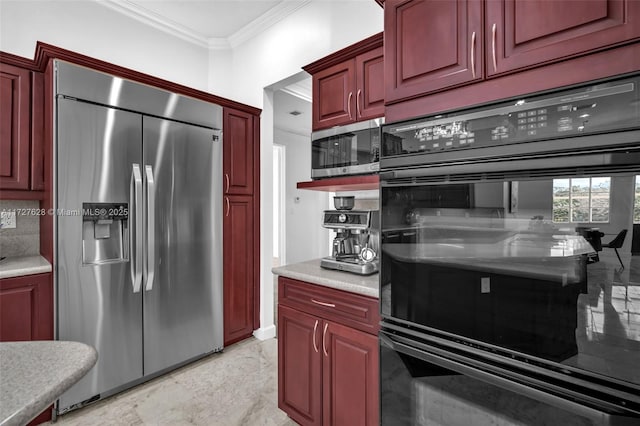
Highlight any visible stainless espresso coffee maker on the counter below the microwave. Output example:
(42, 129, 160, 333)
(320, 198, 380, 275)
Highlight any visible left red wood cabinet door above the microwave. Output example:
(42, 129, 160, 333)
(312, 60, 356, 130)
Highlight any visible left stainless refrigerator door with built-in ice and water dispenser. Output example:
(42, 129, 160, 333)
(55, 97, 142, 412)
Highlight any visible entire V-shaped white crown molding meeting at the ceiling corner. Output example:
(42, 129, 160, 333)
(94, 0, 312, 50)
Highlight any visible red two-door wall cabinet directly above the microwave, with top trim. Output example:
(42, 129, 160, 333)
(303, 33, 384, 130)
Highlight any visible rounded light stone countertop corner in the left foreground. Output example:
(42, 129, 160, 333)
(0, 340, 98, 426)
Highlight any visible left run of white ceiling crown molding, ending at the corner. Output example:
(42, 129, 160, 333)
(94, 0, 209, 48)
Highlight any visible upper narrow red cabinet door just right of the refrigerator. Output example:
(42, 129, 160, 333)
(222, 108, 255, 195)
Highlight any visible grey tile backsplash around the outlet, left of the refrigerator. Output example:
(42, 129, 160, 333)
(0, 200, 40, 257)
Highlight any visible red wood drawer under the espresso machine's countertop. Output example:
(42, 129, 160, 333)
(278, 277, 380, 334)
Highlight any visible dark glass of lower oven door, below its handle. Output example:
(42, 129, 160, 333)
(380, 346, 594, 426)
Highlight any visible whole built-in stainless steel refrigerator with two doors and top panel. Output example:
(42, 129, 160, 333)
(54, 61, 223, 413)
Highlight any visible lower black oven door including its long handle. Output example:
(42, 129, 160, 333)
(380, 331, 640, 426)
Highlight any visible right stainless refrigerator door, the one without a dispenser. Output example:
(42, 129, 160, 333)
(143, 116, 222, 375)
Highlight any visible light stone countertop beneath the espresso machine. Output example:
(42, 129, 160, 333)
(271, 259, 380, 299)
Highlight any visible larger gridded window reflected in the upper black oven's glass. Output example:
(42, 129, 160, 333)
(553, 177, 608, 223)
